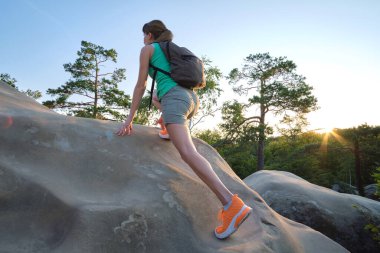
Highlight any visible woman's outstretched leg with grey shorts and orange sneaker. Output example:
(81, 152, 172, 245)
(162, 86, 252, 239)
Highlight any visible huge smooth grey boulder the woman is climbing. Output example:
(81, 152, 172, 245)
(0, 83, 347, 253)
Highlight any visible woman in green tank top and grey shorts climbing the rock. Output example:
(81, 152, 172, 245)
(117, 20, 251, 239)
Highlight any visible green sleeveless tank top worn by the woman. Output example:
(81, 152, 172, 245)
(149, 43, 177, 100)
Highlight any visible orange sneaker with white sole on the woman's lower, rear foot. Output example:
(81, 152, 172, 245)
(214, 194, 252, 239)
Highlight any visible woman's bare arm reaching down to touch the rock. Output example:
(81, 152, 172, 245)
(117, 45, 154, 136)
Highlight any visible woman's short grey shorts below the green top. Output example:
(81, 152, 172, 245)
(161, 85, 199, 125)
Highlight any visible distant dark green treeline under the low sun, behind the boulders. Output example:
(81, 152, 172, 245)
(197, 124, 380, 197)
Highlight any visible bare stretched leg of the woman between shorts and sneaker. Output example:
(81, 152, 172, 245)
(166, 124, 233, 205)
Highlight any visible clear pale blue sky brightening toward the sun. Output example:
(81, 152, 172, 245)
(0, 0, 380, 130)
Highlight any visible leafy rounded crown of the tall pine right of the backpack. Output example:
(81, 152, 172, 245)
(229, 53, 317, 115)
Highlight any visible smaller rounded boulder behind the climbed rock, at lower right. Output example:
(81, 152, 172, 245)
(244, 170, 380, 253)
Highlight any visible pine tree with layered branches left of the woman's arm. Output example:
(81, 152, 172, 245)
(43, 41, 130, 120)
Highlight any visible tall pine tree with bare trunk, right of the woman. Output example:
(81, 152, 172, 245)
(229, 53, 317, 170)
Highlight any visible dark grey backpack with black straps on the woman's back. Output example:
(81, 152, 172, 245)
(149, 41, 206, 108)
